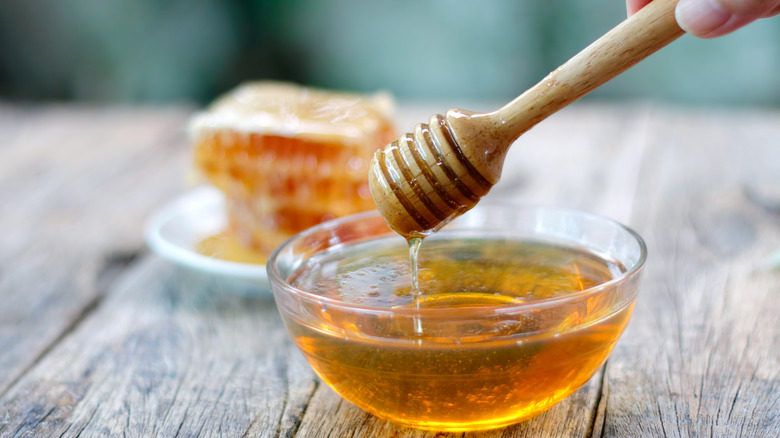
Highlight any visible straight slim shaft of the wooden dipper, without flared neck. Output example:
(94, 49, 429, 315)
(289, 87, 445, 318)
(494, 0, 684, 139)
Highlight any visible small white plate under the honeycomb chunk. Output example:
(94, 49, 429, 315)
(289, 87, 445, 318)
(145, 187, 270, 294)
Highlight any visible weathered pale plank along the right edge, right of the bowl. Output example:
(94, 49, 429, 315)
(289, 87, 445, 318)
(604, 106, 780, 437)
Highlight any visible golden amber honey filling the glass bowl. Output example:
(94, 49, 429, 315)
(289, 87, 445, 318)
(283, 238, 633, 430)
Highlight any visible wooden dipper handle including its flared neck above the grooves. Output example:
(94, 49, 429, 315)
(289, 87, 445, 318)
(446, 0, 684, 184)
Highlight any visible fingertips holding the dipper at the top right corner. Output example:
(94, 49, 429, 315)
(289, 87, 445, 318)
(626, 0, 780, 38)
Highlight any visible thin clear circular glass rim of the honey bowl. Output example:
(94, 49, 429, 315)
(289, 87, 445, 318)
(266, 202, 647, 318)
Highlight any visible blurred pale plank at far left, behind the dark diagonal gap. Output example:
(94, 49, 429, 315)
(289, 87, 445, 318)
(0, 105, 194, 394)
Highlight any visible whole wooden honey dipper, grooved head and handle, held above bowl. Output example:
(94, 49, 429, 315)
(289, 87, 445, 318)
(369, 0, 683, 238)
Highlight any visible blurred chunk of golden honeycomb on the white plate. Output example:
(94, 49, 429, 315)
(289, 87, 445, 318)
(190, 82, 397, 256)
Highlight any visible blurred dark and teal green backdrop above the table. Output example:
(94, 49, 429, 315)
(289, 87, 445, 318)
(0, 0, 780, 106)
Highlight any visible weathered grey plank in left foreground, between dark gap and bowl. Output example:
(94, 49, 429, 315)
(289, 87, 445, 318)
(0, 257, 317, 436)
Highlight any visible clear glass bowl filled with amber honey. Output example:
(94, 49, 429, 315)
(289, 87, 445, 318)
(267, 204, 646, 431)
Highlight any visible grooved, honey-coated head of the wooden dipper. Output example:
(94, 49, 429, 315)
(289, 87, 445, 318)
(368, 112, 495, 238)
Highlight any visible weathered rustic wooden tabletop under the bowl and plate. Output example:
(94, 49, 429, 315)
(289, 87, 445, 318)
(0, 103, 780, 437)
